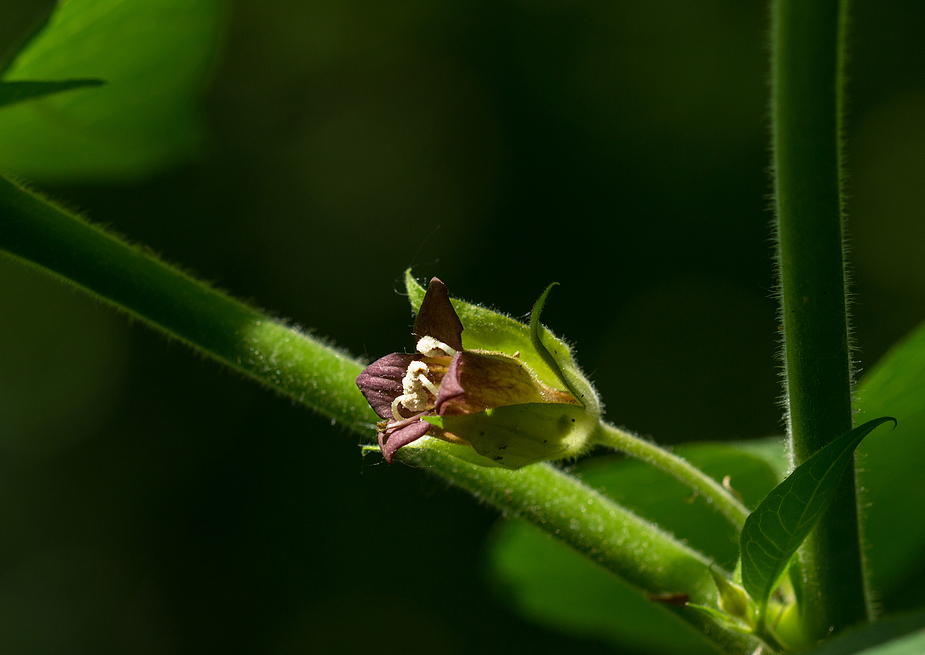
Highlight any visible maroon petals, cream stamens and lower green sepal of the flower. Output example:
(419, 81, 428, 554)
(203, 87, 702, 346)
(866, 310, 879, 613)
(356, 278, 597, 468)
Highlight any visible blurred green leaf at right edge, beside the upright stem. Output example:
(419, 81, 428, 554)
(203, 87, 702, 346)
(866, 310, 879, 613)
(856, 324, 925, 610)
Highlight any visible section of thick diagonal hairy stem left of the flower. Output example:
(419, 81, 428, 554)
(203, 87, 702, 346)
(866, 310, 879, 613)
(0, 178, 368, 430)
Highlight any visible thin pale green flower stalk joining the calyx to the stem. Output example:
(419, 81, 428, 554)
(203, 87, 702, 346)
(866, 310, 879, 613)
(594, 421, 748, 531)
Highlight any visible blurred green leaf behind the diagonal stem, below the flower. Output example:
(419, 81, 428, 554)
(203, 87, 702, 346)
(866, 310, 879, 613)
(490, 444, 777, 653)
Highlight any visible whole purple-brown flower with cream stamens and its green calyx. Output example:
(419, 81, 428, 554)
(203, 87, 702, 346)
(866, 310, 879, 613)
(357, 274, 600, 469)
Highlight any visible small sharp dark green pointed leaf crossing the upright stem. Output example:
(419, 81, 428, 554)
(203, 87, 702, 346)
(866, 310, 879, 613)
(740, 418, 896, 627)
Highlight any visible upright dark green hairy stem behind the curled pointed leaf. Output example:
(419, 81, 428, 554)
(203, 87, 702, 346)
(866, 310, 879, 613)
(771, 0, 868, 639)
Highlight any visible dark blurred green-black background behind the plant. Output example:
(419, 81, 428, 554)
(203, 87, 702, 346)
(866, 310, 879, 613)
(0, 0, 925, 655)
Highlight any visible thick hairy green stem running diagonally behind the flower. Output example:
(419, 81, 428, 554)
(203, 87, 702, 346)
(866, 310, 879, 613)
(0, 173, 750, 653)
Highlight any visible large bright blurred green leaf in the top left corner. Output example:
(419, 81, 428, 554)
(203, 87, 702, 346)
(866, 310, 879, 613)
(0, 0, 222, 181)
